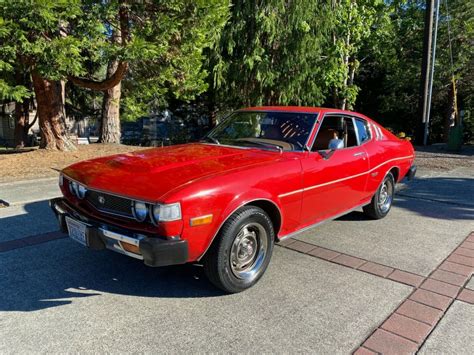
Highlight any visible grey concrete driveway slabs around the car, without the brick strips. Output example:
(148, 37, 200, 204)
(0, 169, 474, 354)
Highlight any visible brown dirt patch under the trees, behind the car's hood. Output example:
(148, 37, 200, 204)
(0, 144, 144, 182)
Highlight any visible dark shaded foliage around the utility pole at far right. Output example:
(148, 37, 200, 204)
(356, 0, 474, 141)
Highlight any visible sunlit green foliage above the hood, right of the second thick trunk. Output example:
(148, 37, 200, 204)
(123, 0, 230, 120)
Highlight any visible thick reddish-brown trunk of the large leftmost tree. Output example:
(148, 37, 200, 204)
(31, 71, 76, 151)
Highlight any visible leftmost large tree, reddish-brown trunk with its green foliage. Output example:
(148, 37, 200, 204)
(0, 0, 106, 150)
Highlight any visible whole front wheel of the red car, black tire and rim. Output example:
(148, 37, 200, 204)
(204, 206, 275, 293)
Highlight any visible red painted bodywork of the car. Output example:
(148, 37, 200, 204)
(63, 106, 414, 261)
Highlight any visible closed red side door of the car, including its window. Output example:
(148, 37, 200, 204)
(301, 114, 369, 226)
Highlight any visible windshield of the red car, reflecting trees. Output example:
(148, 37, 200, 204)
(204, 111, 316, 151)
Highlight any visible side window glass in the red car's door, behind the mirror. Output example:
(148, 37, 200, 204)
(311, 116, 357, 152)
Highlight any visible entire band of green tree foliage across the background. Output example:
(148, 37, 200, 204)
(0, 0, 474, 145)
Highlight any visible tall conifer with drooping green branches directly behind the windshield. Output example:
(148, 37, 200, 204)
(209, 0, 330, 108)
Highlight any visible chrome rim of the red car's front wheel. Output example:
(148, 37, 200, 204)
(229, 222, 268, 281)
